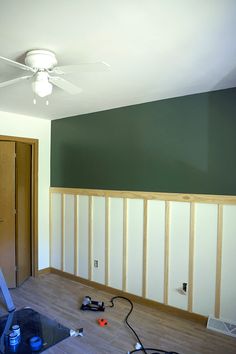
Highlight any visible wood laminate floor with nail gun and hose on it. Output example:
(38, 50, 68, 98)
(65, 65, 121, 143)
(0, 274, 236, 354)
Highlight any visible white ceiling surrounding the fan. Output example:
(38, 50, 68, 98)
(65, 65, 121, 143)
(0, 0, 236, 119)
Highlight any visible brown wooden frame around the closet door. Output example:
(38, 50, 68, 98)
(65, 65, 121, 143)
(0, 135, 39, 277)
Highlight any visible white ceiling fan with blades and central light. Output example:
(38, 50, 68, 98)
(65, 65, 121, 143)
(0, 49, 110, 97)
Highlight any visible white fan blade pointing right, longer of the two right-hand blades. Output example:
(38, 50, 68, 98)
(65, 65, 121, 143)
(52, 61, 110, 75)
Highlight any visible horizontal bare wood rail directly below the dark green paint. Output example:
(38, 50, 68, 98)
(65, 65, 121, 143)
(50, 187, 236, 205)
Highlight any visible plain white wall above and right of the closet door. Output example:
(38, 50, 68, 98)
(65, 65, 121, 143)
(0, 111, 51, 269)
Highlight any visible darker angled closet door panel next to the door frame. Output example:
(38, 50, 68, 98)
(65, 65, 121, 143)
(16, 142, 32, 286)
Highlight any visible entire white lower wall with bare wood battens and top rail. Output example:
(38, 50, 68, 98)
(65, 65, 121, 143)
(50, 188, 236, 321)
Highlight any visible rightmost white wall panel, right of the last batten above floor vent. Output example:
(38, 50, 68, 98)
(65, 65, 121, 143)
(220, 205, 236, 321)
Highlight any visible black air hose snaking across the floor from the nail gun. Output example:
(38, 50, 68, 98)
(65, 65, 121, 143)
(106, 296, 179, 354)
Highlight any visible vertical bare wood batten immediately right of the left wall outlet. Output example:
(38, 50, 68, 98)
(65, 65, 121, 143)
(105, 197, 110, 285)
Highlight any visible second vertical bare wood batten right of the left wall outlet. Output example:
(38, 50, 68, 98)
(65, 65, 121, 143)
(122, 198, 128, 291)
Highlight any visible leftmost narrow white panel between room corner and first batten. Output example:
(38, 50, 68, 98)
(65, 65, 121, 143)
(50, 193, 62, 270)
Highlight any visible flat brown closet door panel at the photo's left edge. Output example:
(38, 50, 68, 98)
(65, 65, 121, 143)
(0, 141, 16, 288)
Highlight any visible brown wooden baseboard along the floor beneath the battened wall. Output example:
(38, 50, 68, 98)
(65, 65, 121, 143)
(39, 268, 207, 326)
